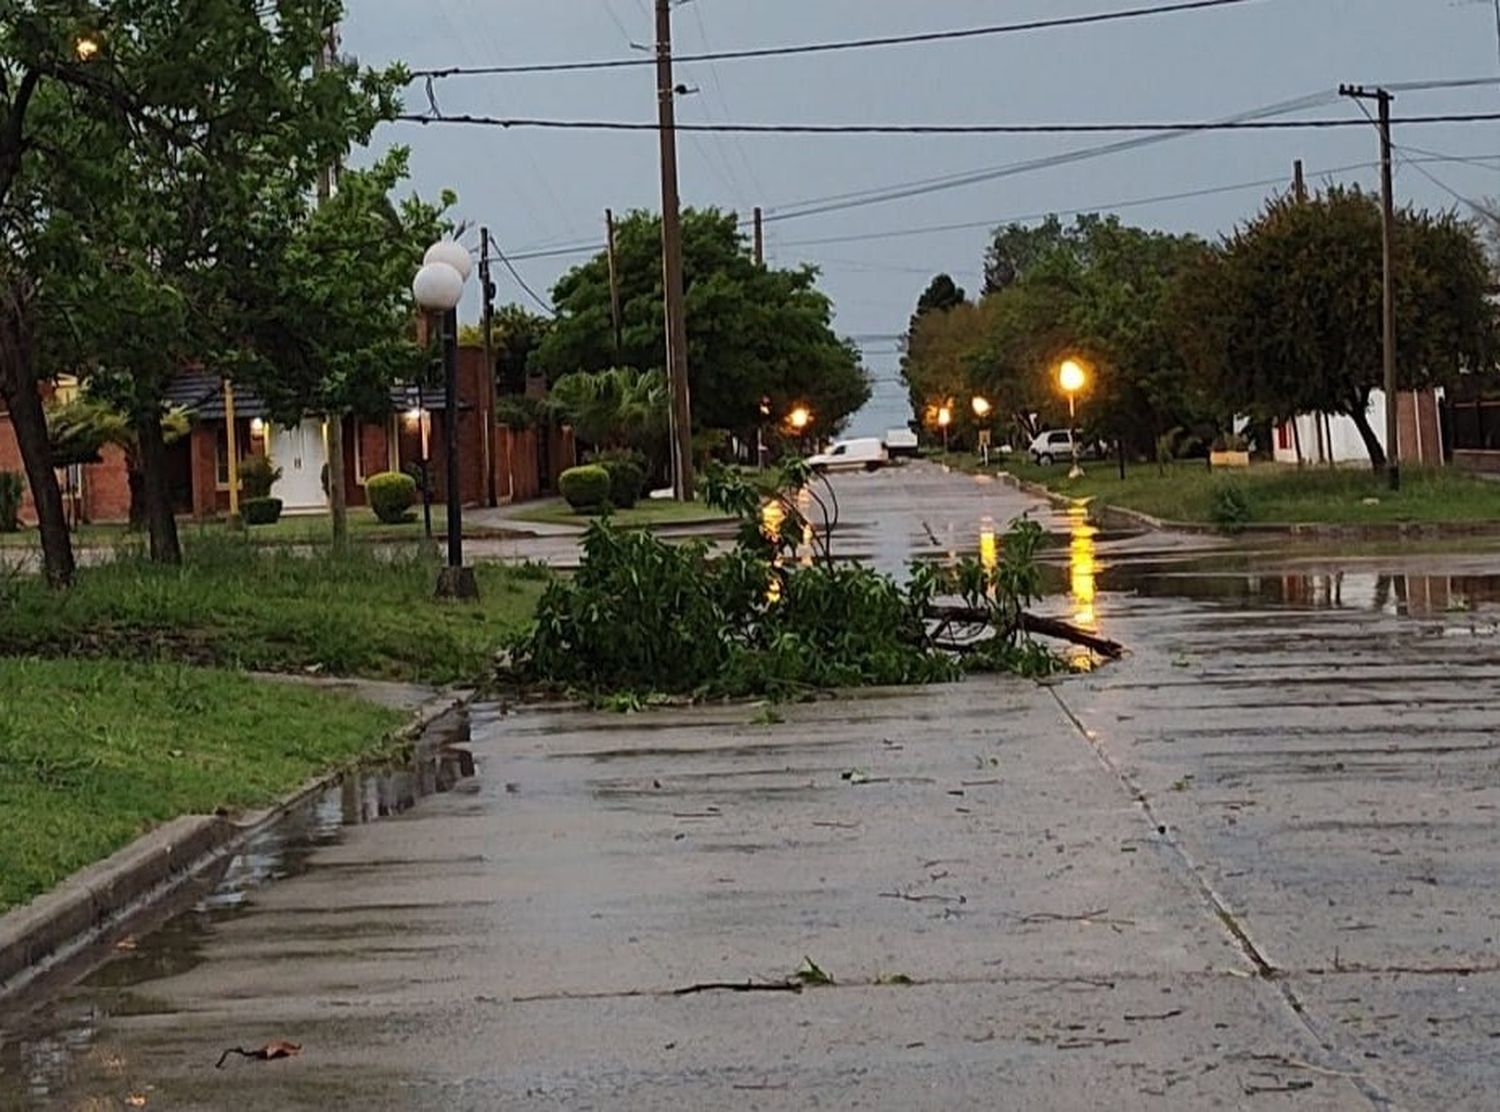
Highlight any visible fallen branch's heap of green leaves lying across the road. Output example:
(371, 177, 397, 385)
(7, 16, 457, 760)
(513, 465, 1058, 698)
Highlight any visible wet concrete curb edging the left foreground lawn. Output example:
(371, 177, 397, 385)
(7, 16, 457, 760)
(0, 692, 474, 999)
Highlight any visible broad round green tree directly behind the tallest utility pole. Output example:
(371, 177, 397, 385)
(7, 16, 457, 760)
(531, 210, 870, 438)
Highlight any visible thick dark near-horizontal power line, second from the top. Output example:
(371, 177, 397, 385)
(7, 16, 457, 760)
(396, 113, 1500, 135)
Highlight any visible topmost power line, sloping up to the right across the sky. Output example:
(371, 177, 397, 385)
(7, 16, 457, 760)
(411, 0, 1262, 80)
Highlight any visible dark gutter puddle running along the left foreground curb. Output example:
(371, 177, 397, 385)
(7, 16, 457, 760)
(0, 714, 474, 1107)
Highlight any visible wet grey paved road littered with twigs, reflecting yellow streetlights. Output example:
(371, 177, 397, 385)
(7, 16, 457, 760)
(0, 468, 1500, 1109)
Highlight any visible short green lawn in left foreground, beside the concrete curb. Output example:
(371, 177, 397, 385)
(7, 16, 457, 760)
(0, 659, 404, 911)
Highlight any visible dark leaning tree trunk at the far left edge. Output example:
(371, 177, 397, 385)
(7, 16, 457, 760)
(0, 291, 75, 588)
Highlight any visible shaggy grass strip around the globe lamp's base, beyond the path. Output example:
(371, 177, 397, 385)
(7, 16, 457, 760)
(0, 537, 546, 683)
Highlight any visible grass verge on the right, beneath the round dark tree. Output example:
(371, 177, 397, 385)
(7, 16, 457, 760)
(999, 459, 1500, 525)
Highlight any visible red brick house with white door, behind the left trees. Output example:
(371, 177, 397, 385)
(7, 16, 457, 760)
(0, 347, 575, 522)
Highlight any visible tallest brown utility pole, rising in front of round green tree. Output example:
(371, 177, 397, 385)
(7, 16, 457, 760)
(656, 0, 693, 501)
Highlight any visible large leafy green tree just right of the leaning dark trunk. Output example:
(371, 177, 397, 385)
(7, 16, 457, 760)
(0, 0, 404, 561)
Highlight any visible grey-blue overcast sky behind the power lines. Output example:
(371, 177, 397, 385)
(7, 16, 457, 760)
(344, 0, 1500, 435)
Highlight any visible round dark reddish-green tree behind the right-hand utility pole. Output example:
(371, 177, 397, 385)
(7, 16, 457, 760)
(1172, 188, 1500, 470)
